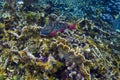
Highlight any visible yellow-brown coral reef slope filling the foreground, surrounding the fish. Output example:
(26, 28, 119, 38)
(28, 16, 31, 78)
(0, 0, 120, 80)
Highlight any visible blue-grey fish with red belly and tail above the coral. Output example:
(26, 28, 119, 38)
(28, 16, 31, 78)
(40, 21, 76, 36)
